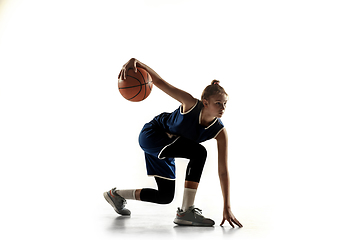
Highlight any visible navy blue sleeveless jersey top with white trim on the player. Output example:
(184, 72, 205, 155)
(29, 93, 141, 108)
(151, 100, 224, 143)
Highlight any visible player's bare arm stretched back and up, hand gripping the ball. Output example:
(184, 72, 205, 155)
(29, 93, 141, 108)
(118, 58, 197, 112)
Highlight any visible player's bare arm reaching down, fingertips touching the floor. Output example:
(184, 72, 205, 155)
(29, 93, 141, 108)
(216, 128, 242, 227)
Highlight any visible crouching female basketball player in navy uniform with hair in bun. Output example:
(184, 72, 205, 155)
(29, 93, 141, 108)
(104, 58, 242, 227)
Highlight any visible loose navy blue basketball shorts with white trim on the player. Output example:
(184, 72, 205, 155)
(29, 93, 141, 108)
(139, 122, 178, 180)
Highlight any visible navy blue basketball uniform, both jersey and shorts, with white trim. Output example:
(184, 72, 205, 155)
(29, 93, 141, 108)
(139, 100, 224, 180)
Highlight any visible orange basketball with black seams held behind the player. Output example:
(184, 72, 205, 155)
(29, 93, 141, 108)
(118, 68, 153, 102)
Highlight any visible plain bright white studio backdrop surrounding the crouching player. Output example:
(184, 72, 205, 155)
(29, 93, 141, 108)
(0, 0, 360, 239)
